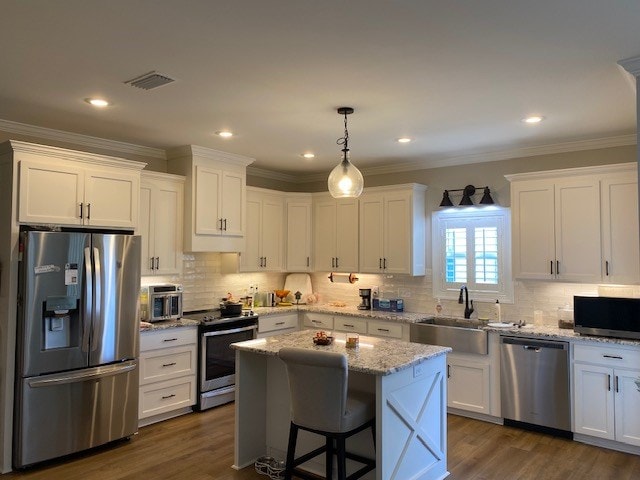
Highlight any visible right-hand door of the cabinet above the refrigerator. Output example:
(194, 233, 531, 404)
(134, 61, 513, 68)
(84, 171, 140, 228)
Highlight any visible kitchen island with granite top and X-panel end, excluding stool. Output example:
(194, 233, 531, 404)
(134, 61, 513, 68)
(232, 330, 451, 480)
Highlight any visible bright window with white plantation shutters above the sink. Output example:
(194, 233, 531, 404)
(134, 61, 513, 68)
(432, 207, 513, 303)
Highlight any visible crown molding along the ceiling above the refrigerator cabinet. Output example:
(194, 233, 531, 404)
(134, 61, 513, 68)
(0, 119, 167, 160)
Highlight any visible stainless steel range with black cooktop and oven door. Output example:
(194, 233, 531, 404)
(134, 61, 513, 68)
(183, 310, 258, 410)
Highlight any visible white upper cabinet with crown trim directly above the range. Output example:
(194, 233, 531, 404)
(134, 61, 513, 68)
(167, 145, 253, 252)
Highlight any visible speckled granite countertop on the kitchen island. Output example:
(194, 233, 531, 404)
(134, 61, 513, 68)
(231, 330, 451, 375)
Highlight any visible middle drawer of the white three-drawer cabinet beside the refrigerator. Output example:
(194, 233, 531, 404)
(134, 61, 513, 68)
(140, 345, 197, 385)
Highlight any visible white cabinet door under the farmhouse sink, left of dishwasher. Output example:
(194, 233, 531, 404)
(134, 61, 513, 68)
(447, 355, 491, 415)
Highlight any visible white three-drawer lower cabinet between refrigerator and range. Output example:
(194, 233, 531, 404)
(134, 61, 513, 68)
(138, 326, 198, 426)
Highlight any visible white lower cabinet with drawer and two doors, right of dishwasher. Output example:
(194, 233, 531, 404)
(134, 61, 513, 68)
(573, 345, 640, 446)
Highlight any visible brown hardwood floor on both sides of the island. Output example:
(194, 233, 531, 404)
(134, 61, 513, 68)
(2, 404, 640, 480)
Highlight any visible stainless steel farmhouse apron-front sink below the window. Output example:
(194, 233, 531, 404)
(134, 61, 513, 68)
(409, 317, 488, 355)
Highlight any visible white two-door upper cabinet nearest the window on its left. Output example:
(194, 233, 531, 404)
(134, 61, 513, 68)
(359, 185, 426, 275)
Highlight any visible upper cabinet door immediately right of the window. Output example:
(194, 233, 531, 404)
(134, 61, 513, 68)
(511, 181, 556, 280)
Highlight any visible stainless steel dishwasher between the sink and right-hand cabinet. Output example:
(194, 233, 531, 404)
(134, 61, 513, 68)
(500, 336, 571, 433)
